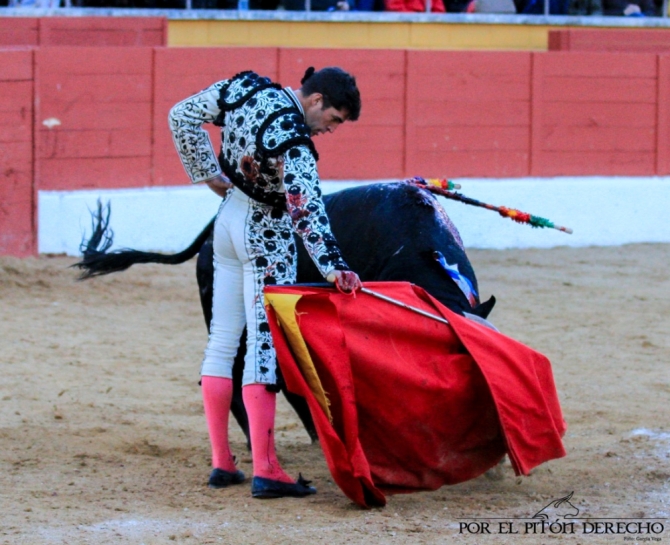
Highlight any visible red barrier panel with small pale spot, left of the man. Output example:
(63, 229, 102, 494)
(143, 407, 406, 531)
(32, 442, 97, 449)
(35, 47, 153, 189)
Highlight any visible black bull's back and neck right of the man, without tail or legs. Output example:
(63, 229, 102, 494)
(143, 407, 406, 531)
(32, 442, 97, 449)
(298, 183, 478, 311)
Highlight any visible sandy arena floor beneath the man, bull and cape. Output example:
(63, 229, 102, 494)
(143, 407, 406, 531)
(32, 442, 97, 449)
(0, 244, 670, 545)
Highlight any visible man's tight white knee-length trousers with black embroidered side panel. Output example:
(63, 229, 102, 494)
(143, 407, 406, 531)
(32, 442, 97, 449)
(200, 188, 296, 386)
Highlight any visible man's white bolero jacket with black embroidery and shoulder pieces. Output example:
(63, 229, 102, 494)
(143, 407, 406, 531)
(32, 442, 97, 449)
(168, 72, 349, 276)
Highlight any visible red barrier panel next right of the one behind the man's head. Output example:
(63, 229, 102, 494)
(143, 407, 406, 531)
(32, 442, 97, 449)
(405, 51, 531, 177)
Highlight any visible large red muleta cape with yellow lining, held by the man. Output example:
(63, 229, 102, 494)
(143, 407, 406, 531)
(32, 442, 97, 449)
(265, 282, 566, 507)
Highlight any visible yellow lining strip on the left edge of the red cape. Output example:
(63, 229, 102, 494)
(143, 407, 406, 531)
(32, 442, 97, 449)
(265, 293, 333, 422)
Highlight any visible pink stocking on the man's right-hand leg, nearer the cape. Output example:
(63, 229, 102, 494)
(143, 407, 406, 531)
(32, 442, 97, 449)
(242, 384, 294, 483)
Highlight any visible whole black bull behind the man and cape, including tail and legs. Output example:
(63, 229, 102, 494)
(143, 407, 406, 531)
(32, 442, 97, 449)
(76, 182, 495, 440)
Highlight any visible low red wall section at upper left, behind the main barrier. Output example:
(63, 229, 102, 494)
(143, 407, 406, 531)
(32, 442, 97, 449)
(0, 17, 167, 47)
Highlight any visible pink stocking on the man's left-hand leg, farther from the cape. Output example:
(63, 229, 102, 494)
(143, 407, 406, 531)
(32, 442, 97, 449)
(201, 376, 236, 472)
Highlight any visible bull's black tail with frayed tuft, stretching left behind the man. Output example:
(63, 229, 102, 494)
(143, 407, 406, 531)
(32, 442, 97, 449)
(72, 201, 214, 280)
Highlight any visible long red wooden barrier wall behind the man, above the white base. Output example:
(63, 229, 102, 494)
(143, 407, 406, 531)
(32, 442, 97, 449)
(0, 47, 670, 255)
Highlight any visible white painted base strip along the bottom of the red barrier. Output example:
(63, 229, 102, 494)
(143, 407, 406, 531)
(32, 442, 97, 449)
(38, 177, 670, 255)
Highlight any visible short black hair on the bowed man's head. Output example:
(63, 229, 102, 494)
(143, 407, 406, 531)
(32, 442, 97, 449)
(300, 66, 361, 121)
